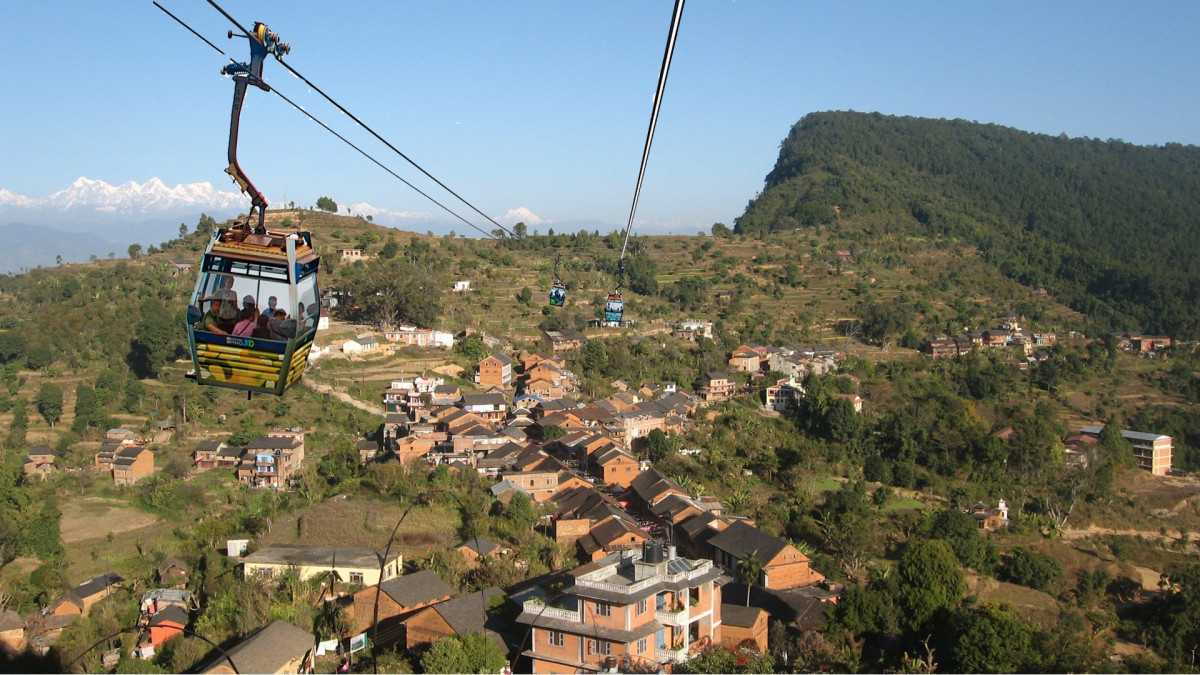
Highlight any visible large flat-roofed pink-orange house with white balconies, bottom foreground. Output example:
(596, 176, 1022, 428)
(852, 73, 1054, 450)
(515, 542, 721, 673)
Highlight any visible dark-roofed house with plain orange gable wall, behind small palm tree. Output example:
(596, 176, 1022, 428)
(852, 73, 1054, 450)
(708, 520, 824, 590)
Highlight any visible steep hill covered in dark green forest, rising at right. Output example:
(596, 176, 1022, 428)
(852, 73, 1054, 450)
(737, 112, 1200, 339)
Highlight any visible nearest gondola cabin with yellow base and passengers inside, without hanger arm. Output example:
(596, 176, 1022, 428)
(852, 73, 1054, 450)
(187, 226, 320, 395)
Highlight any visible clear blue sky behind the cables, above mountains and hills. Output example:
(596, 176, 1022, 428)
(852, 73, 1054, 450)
(0, 0, 1200, 234)
